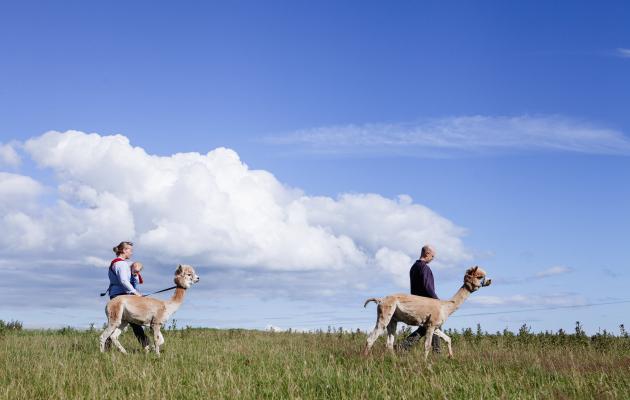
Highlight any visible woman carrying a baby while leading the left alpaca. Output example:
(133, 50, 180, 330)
(108, 242, 149, 349)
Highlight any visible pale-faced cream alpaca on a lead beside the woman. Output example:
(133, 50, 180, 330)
(100, 265, 199, 355)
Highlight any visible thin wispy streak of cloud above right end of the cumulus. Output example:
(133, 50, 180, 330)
(268, 115, 630, 157)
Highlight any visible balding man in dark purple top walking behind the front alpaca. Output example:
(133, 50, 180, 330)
(399, 245, 440, 353)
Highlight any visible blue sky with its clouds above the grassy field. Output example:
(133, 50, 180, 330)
(0, 1, 630, 331)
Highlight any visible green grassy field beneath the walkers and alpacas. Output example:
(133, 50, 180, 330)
(0, 328, 630, 399)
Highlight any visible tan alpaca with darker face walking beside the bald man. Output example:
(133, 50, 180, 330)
(363, 267, 492, 360)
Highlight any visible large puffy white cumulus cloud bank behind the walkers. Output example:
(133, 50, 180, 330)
(0, 131, 470, 286)
